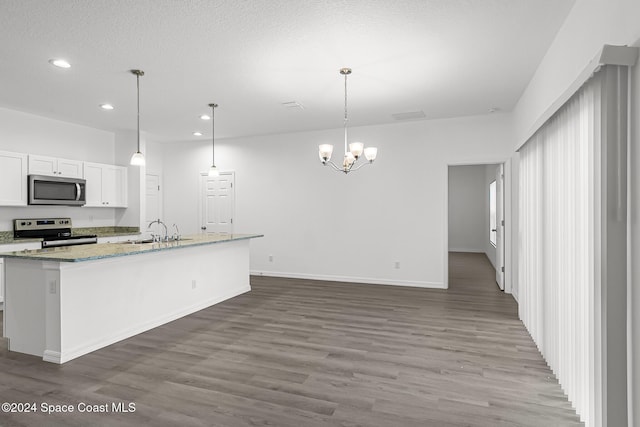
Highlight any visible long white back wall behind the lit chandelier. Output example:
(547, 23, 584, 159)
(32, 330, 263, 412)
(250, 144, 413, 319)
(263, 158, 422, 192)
(164, 114, 512, 287)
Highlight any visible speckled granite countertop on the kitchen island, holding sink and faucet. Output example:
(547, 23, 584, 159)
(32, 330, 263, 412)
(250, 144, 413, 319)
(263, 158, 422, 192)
(0, 234, 263, 262)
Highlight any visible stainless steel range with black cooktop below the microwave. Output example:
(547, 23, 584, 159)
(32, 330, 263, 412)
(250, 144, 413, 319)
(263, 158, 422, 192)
(13, 218, 98, 248)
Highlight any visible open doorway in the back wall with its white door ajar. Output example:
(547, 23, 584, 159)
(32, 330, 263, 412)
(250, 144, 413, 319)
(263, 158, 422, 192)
(444, 161, 511, 293)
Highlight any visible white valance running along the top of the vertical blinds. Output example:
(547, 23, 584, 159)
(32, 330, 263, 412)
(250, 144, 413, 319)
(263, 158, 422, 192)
(516, 44, 638, 151)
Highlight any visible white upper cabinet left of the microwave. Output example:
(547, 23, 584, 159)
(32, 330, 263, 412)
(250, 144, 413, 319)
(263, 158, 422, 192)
(0, 151, 27, 206)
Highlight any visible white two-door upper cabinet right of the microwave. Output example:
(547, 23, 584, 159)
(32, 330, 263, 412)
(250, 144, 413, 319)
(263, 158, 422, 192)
(84, 162, 127, 208)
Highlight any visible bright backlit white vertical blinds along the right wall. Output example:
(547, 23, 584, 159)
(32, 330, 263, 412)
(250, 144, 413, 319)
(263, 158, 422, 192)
(518, 69, 602, 425)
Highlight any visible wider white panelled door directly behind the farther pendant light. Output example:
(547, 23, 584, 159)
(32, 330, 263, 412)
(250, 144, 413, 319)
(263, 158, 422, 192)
(200, 172, 235, 233)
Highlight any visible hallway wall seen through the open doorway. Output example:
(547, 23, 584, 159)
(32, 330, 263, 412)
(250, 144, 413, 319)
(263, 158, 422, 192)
(449, 165, 488, 252)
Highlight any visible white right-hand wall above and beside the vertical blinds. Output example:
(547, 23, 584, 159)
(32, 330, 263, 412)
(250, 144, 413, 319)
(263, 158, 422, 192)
(514, 0, 640, 426)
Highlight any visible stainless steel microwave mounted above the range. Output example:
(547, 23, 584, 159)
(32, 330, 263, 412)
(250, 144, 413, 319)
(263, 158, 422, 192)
(29, 175, 86, 206)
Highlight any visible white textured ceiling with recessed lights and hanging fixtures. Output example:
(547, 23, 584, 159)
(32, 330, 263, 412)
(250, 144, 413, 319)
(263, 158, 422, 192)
(0, 0, 574, 141)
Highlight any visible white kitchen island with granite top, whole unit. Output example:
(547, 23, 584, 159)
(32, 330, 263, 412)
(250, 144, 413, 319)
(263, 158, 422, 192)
(0, 234, 262, 363)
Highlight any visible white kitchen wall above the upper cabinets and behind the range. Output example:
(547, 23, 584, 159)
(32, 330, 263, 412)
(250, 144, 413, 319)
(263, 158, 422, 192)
(0, 108, 128, 230)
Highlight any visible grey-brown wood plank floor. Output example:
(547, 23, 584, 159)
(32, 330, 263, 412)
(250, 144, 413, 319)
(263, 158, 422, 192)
(0, 253, 581, 427)
